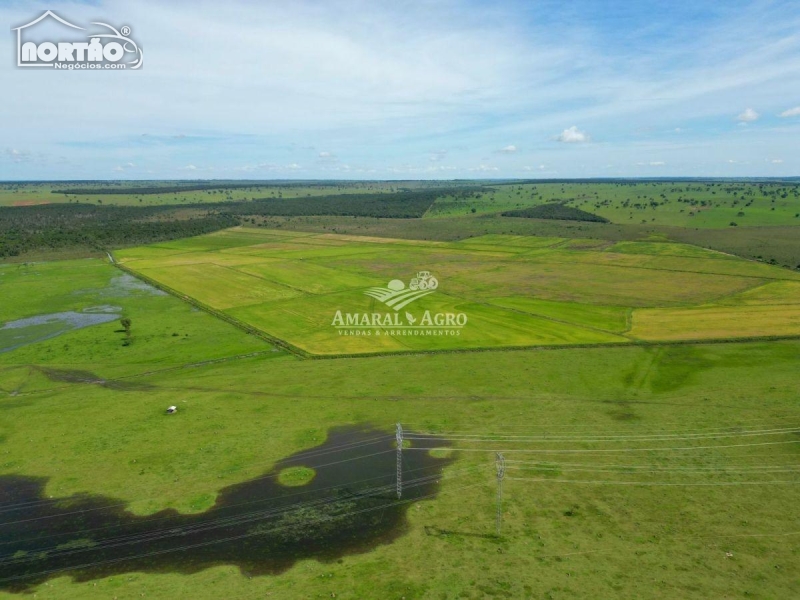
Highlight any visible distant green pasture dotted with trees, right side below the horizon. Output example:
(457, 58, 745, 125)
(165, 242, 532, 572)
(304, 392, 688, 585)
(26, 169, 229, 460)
(426, 181, 800, 228)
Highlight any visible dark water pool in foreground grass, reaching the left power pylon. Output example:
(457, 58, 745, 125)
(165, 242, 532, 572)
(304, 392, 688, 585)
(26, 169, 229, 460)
(0, 427, 452, 592)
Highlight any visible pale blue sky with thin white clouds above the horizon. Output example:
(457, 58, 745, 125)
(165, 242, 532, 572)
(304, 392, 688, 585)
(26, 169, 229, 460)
(0, 0, 800, 180)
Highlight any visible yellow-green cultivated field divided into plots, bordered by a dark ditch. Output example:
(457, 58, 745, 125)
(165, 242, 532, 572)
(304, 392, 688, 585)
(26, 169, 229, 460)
(117, 228, 800, 356)
